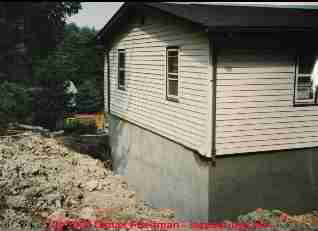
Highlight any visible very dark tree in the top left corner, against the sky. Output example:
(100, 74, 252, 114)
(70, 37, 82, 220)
(0, 2, 81, 83)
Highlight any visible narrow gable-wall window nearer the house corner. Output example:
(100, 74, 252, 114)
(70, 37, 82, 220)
(167, 47, 179, 101)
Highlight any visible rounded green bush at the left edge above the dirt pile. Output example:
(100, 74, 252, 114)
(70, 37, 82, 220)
(0, 81, 31, 131)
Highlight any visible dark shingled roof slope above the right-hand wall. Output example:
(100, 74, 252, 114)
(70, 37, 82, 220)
(144, 3, 318, 28)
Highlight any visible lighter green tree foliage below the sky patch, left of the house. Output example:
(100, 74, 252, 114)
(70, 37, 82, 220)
(34, 23, 104, 86)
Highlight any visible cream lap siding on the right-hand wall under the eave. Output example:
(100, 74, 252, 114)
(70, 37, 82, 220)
(216, 49, 318, 155)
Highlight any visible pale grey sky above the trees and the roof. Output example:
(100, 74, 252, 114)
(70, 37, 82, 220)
(67, 2, 318, 30)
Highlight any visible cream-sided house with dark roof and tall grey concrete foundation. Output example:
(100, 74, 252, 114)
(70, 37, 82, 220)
(97, 3, 318, 220)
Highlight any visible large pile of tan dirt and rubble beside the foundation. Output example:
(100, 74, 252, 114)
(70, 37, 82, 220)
(0, 132, 174, 231)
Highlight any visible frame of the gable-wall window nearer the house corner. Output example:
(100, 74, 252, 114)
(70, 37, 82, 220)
(166, 46, 180, 102)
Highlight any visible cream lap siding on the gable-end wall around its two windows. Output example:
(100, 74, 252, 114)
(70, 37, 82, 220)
(110, 16, 209, 155)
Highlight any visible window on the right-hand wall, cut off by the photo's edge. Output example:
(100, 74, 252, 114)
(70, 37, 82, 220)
(295, 53, 318, 105)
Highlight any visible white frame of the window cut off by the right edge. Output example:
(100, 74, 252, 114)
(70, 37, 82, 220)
(293, 54, 318, 107)
